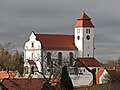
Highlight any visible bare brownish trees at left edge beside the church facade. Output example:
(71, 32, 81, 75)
(0, 42, 23, 76)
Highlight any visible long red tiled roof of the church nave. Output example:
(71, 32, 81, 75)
(35, 34, 76, 50)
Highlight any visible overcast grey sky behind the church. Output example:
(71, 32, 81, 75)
(0, 0, 120, 62)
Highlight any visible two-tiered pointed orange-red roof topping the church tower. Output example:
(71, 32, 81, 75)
(74, 11, 94, 28)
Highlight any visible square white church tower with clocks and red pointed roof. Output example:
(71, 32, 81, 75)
(74, 12, 94, 58)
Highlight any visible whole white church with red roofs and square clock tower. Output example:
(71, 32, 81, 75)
(24, 12, 100, 86)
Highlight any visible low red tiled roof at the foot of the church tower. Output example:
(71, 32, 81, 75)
(76, 58, 100, 67)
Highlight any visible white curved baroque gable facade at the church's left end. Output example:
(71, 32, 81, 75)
(24, 32, 41, 71)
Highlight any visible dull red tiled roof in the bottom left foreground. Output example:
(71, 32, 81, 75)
(3, 78, 45, 90)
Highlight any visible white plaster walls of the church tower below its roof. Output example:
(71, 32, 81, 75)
(74, 27, 94, 57)
